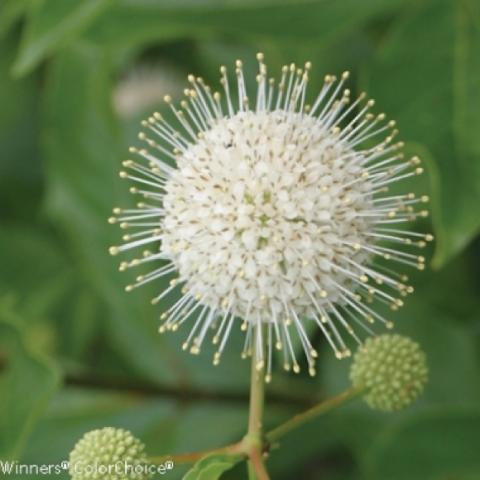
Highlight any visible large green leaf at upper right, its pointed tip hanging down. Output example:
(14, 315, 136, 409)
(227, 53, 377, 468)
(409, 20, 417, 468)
(367, 0, 480, 267)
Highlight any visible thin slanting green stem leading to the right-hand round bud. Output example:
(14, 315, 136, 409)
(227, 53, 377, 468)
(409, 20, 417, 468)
(266, 387, 363, 443)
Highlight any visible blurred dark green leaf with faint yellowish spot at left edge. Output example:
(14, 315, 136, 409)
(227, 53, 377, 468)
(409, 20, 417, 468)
(0, 223, 112, 360)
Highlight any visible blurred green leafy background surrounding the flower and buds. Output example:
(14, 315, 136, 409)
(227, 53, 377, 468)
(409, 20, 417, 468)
(0, 0, 480, 480)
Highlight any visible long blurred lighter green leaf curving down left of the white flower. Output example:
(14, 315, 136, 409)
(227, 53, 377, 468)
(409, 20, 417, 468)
(40, 44, 181, 386)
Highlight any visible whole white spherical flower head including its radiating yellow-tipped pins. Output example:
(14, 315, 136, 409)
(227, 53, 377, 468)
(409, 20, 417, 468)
(110, 54, 432, 380)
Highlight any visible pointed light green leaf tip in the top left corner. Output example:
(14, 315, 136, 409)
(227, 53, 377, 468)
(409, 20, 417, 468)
(13, 0, 112, 76)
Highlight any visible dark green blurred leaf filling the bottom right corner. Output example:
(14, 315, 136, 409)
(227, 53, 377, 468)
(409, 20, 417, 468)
(368, 407, 480, 480)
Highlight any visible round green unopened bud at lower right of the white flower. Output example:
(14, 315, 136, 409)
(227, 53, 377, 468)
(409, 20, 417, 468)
(350, 334, 428, 411)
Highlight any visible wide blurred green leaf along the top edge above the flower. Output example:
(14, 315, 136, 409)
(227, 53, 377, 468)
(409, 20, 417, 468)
(84, 0, 409, 50)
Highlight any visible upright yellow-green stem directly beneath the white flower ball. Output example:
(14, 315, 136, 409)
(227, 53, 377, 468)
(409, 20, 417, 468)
(243, 326, 270, 480)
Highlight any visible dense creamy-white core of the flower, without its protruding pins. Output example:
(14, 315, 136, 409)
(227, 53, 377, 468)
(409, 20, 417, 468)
(161, 110, 373, 323)
